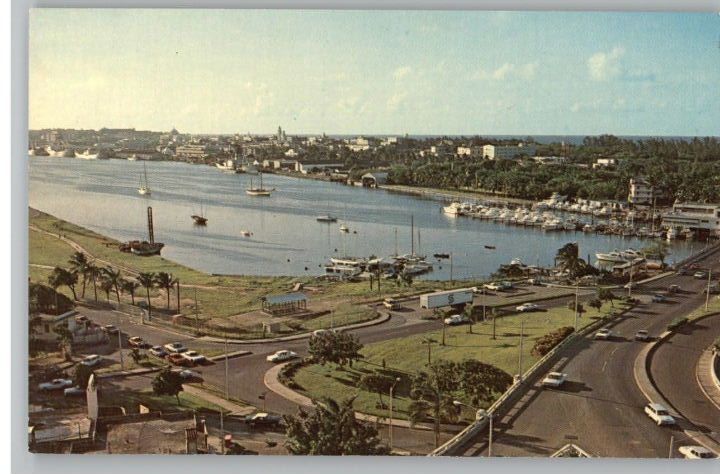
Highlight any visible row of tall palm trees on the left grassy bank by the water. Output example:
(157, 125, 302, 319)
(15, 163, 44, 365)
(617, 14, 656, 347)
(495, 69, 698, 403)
(48, 252, 180, 311)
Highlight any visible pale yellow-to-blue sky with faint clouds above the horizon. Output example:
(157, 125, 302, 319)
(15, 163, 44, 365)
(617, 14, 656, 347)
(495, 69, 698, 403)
(29, 9, 720, 136)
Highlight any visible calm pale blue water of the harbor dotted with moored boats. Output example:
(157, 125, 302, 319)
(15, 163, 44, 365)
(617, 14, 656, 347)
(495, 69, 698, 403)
(29, 157, 702, 279)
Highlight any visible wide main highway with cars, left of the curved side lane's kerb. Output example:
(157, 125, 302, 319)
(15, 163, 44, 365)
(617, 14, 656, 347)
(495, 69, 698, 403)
(456, 250, 720, 457)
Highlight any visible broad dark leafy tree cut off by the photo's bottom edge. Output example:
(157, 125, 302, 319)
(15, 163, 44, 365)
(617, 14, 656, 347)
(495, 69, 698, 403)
(284, 398, 389, 456)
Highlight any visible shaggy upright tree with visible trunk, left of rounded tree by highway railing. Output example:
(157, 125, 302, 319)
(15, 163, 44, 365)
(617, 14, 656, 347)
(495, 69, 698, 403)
(409, 360, 458, 447)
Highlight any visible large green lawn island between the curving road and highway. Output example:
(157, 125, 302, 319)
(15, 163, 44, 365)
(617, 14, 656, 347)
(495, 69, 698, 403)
(293, 304, 612, 418)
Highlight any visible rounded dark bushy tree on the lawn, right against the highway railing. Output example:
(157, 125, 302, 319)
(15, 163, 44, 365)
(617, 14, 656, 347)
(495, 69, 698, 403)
(458, 359, 513, 406)
